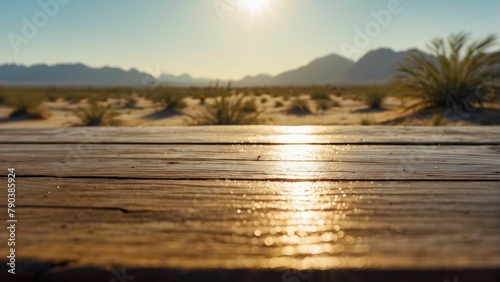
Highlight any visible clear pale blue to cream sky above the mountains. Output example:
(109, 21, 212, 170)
(0, 0, 500, 79)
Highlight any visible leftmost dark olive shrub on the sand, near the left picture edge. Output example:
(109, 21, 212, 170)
(8, 95, 51, 119)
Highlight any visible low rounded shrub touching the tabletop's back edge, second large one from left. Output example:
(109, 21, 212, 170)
(72, 101, 123, 126)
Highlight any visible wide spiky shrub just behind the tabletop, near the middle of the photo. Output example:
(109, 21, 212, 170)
(192, 94, 261, 125)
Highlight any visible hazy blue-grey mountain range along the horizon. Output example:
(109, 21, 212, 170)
(0, 49, 500, 87)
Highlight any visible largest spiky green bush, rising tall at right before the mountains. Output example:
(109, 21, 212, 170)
(396, 33, 498, 108)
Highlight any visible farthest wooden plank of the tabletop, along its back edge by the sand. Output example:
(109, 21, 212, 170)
(0, 126, 500, 145)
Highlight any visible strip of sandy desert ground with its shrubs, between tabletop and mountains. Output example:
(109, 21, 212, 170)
(0, 55, 500, 126)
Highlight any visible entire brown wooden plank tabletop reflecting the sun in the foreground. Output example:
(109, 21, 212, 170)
(0, 126, 500, 282)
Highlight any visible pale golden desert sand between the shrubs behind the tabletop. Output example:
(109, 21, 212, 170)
(0, 94, 500, 127)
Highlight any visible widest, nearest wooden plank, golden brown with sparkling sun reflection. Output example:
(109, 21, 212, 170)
(0, 178, 500, 270)
